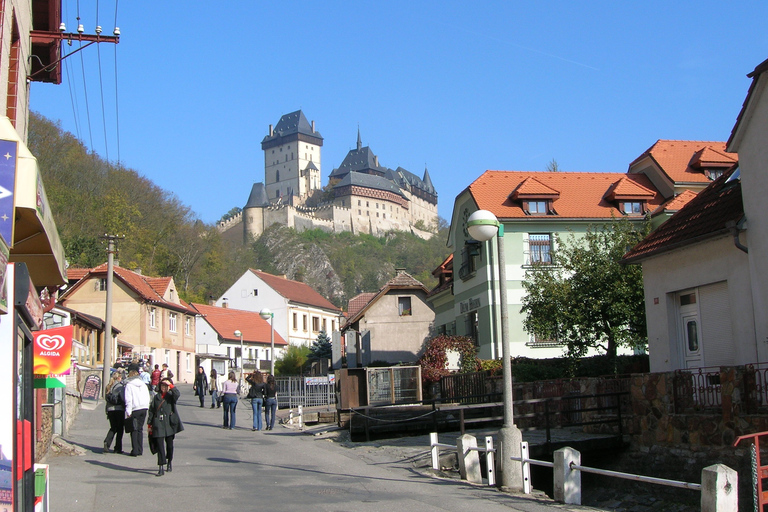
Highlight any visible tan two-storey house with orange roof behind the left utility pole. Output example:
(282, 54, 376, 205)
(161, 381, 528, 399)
(59, 263, 197, 382)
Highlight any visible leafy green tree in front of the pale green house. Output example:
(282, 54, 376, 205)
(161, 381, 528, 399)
(522, 219, 648, 357)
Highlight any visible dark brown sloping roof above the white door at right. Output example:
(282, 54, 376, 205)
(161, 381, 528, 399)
(622, 167, 744, 263)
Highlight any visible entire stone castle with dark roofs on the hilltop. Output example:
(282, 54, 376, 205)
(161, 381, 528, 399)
(217, 110, 437, 243)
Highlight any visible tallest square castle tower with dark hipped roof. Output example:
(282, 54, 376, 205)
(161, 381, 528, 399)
(261, 110, 323, 204)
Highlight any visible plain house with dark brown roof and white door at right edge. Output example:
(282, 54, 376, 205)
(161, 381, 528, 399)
(624, 56, 768, 372)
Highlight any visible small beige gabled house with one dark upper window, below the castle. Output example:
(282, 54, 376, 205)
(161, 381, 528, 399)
(342, 269, 435, 368)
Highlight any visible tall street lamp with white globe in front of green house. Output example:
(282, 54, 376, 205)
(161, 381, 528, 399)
(467, 210, 523, 491)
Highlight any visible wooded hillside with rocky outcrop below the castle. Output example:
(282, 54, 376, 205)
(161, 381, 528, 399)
(29, 113, 448, 307)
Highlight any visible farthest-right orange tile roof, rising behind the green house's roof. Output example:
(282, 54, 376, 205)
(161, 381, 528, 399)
(629, 139, 739, 183)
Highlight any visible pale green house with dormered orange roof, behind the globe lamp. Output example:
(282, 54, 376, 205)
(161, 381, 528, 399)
(438, 171, 666, 359)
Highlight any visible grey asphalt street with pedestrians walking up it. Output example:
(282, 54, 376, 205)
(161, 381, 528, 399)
(45, 384, 597, 512)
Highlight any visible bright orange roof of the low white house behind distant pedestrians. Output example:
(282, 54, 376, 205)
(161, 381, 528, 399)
(192, 303, 288, 346)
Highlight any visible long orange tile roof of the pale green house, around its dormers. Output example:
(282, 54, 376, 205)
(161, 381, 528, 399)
(469, 171, 663, 219)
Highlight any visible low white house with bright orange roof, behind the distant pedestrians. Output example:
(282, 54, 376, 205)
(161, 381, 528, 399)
(192, 303, 288, 377)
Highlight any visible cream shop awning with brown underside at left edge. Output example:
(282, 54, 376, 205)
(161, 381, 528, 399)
(0, 116, 66, 287)
